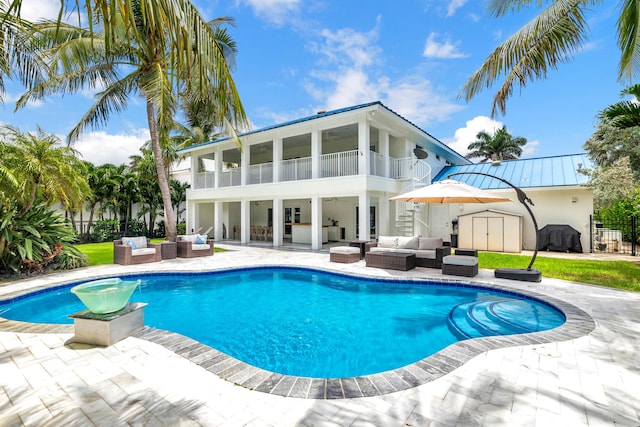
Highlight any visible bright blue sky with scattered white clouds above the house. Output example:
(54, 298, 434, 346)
(0, 0, 628, 164)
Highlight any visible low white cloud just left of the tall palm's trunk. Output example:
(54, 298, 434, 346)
(73, 129, 150, 165)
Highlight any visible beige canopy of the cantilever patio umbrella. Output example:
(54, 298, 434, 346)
(391, 179, 509, 203)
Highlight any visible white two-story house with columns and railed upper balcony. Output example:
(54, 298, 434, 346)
(180, 102, 592, 250)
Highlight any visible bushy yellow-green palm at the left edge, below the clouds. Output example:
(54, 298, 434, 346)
(0, 126, 91, 216)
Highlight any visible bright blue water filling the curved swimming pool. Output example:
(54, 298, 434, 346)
(0, 267, 565, 378)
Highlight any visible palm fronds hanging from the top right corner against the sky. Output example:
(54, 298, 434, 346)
(460, 0, 640, 116)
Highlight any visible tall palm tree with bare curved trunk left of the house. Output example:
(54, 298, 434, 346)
(17, 0, 247, 240)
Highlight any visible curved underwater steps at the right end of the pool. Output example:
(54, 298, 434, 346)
(448, 300, 539, 339)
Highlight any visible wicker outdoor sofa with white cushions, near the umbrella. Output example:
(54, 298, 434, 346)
(365, 236, 451, 268)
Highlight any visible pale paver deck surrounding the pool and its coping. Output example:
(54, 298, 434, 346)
(0, 245, 640, 427)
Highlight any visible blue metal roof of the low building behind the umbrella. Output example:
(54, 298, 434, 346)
(433, 153, 593, 190)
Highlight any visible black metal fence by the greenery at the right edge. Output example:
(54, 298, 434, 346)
(590, 212, 640, 256)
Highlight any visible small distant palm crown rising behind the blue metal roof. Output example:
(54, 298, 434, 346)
(466, 126, 527, 162)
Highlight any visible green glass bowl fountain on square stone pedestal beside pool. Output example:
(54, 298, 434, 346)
(69, 278, 147, 346)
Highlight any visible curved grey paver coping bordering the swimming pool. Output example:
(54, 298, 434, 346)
(0, 265, 596, 399)
